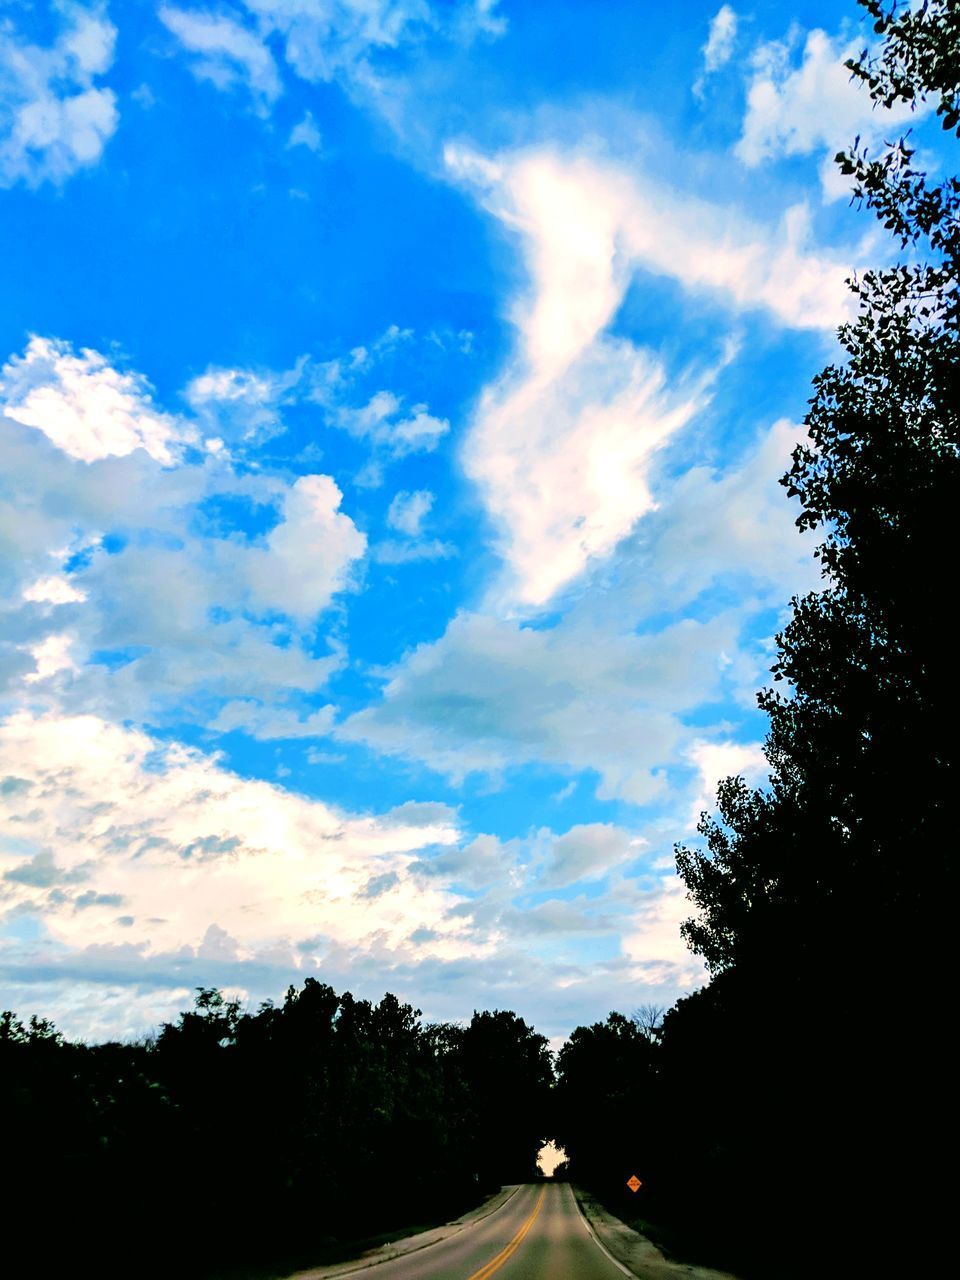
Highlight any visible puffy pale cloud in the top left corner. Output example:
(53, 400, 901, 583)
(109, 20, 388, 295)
(0, 3, 119, 187)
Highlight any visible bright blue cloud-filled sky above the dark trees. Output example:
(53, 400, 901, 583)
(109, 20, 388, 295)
(0, 0, 923, 1042)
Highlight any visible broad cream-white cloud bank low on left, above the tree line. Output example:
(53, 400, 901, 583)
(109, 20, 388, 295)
(0, 713, 471, 973)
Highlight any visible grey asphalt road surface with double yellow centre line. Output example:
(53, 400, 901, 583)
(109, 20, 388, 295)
(358, 1183, 623, 1280)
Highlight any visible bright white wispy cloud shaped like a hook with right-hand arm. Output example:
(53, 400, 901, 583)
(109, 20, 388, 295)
(447, 146, 849, 607)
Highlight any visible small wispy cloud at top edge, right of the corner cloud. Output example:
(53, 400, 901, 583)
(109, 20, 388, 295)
(159, 5, 283, 115)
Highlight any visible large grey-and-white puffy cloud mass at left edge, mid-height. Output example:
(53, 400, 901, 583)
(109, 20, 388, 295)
(0, 339, 366, 719)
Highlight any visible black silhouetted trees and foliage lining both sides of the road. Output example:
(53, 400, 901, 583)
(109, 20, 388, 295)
(0, 0, 960, 1280)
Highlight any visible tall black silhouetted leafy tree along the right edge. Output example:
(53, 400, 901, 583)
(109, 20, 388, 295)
(664, 0, 960, 1275)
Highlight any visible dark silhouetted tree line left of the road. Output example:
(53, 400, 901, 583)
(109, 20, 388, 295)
(0, 978, 552, 1276)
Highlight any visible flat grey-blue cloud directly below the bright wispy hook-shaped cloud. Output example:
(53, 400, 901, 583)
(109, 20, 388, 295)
(335, 613, 739, 804)
